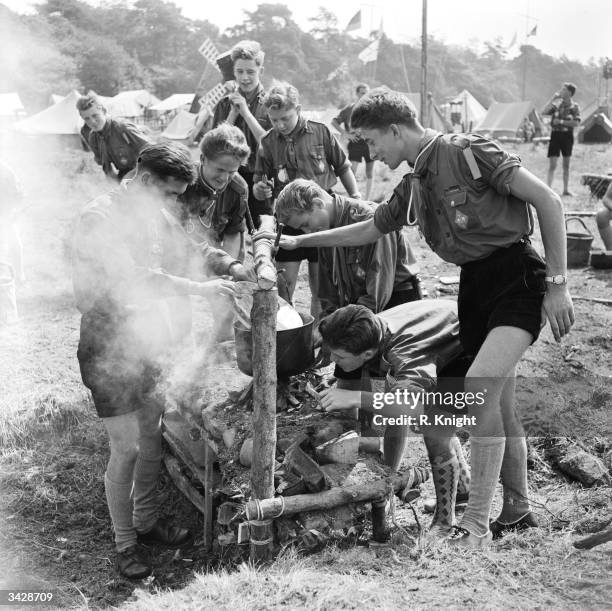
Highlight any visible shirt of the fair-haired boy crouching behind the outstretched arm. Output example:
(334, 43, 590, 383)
(318, 193, 418, 316)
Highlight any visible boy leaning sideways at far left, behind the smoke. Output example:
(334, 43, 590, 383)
(76, 92, 151, 181)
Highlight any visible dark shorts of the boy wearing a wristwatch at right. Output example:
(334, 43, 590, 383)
(458, 239, 546, 356)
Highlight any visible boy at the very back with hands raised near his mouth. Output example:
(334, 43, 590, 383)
(213, 40, 272, 229)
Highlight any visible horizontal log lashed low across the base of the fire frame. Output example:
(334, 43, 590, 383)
(246, 469, 426, 520)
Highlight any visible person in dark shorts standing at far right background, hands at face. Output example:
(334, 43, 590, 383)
(542, 83, 580, 195)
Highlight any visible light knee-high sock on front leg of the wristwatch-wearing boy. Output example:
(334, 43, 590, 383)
(460, 437, 506, 537)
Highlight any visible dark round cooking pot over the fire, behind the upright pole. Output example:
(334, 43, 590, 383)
(234, 312, 314, 378)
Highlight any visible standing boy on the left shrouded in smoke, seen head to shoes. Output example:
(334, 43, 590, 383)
(73, 144, 245, 579)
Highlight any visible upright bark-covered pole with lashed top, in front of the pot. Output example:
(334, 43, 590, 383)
(250, 216, 278, 562)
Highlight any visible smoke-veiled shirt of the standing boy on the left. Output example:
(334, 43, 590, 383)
(73, 184, 235, 315)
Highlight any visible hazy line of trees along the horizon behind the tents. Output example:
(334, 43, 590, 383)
(0, 0, 603, 110)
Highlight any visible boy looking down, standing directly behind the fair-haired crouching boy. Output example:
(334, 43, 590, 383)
(253, 85, 361, 316)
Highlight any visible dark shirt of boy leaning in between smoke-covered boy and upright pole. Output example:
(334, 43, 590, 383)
(179, 168, 249, 245)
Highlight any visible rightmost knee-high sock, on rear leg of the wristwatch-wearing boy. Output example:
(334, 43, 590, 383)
(498, 437, 530, 523)
